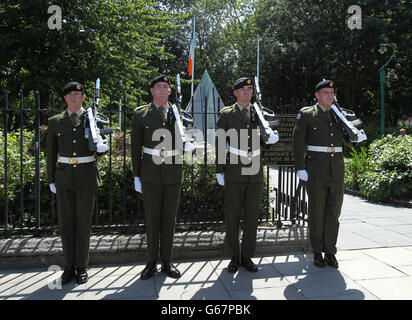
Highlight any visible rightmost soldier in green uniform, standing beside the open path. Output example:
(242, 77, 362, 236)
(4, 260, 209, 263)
(293, 80, 366, 268)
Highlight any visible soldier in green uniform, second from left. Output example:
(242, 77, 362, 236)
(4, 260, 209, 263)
(131, 75, 193, 280)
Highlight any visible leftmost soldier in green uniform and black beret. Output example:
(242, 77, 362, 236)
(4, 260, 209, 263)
(47, 82, 108, 284)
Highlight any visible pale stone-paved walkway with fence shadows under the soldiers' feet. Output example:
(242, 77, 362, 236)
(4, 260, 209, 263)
(0, 195, 412, 300)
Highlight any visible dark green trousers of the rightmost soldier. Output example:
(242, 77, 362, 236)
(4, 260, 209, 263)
(307, 177, 344, 254)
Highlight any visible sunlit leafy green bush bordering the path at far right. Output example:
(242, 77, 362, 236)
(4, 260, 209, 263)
(345, 135, 412, 201)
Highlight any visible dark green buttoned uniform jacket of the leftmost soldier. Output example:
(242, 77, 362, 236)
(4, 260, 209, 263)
(47, 111, 101, 189)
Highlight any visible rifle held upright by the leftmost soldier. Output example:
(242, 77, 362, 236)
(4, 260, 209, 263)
(85, 78, 113, 151)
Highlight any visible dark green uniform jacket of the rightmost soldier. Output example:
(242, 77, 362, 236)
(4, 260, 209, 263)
(293, 104, 344, 179)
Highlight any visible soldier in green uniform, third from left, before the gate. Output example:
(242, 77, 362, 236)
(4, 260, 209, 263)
(216, 77, 278, 273)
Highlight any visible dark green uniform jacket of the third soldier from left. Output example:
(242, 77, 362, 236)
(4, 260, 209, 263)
(216, 103, 263, 183)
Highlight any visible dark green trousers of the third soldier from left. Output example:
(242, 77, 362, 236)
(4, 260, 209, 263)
(225, 181, 263, 258)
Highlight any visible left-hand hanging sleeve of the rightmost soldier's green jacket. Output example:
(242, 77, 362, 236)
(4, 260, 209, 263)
(293, 112, 308, 170)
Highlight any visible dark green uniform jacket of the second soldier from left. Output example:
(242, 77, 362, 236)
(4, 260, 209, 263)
(131, 103, 183, 184)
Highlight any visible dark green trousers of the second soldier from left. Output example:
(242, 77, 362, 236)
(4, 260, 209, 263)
(142, 182, 181, 261)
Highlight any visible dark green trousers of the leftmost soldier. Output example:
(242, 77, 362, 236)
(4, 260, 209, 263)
(56, 188, 97, 268)
